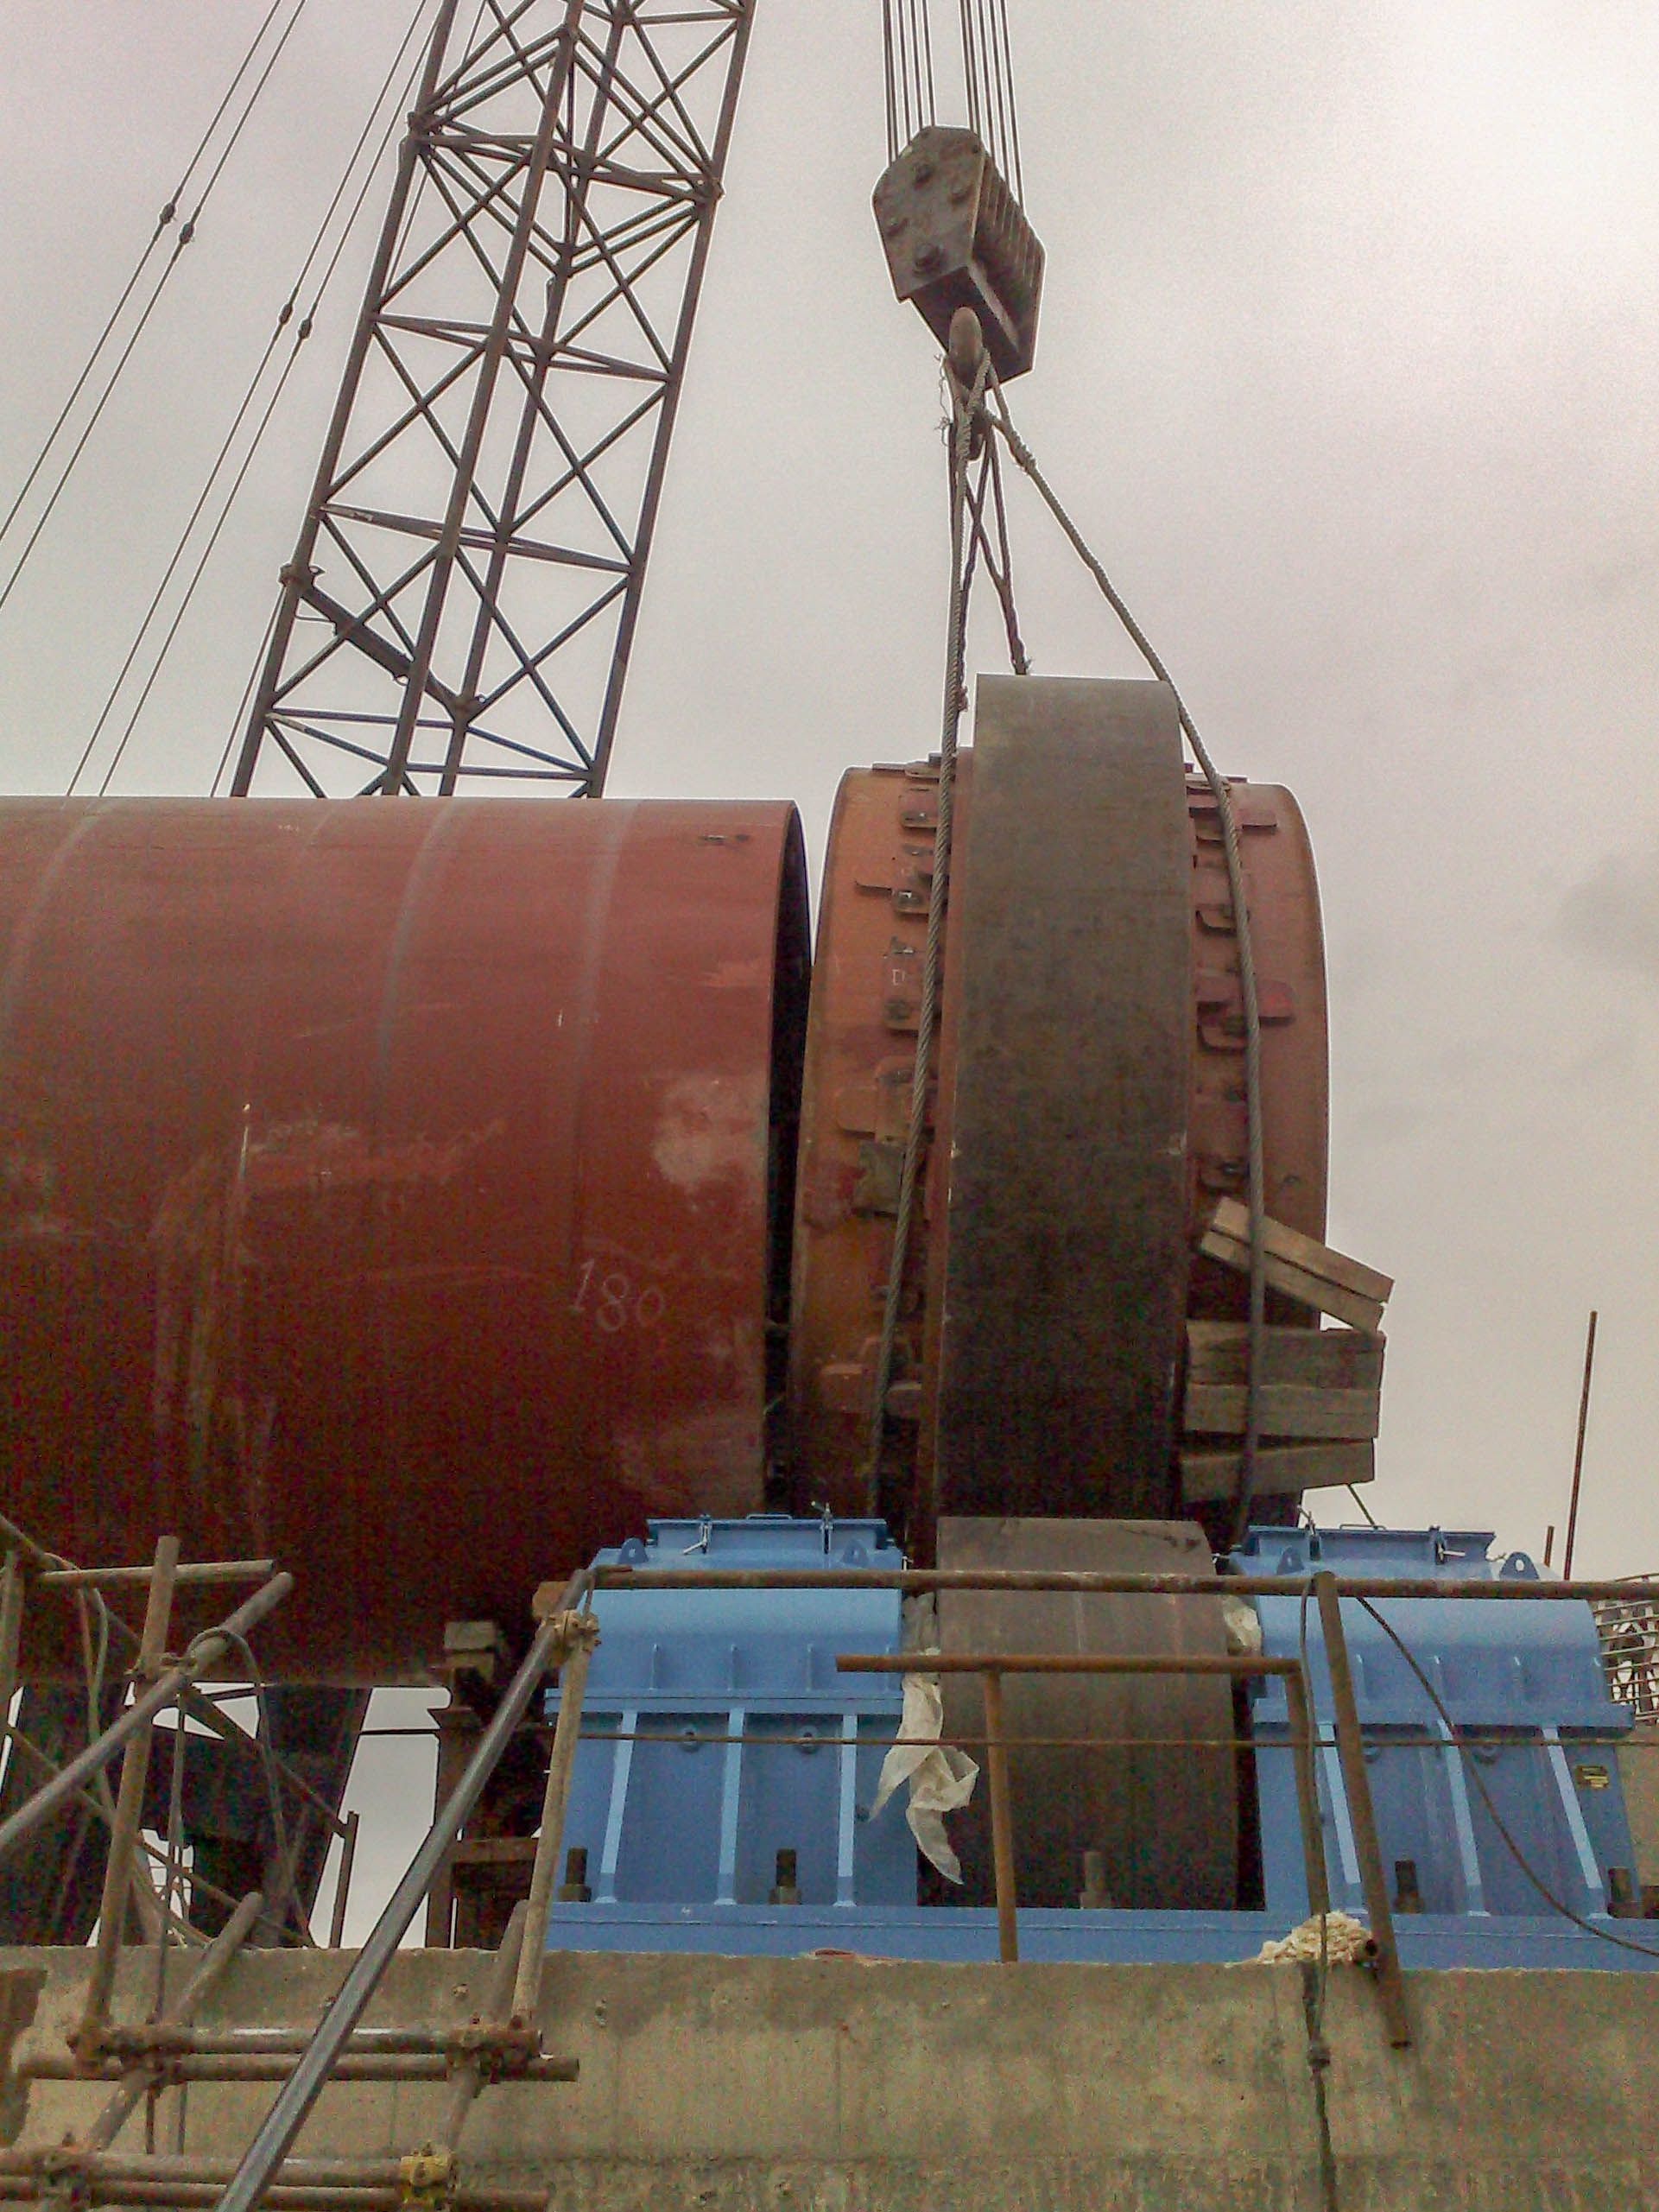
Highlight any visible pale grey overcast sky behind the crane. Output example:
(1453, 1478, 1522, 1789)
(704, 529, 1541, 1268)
(0, 0, 1659, 1937)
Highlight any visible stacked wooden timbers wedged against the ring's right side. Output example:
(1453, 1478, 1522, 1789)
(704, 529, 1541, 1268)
(1181, 1199, 1394, 1506)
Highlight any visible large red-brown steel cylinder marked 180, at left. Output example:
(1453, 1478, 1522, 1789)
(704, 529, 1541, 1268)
(0, 801, 807, 1681)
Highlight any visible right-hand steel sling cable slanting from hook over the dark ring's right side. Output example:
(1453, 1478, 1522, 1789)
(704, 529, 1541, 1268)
(989, 376, 1268, 1546)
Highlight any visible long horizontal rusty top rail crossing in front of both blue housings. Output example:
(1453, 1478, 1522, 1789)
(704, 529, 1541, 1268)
(592, 1566, 1659, 1604)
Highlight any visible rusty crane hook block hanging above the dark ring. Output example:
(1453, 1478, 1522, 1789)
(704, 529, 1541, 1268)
(874, 124, 1042, 383)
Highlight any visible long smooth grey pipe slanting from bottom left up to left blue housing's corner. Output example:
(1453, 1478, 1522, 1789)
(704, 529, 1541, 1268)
(221, 1610, 579, 2212)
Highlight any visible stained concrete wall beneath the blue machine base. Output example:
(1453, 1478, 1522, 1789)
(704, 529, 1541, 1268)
(0, 1951, 1659, 2212)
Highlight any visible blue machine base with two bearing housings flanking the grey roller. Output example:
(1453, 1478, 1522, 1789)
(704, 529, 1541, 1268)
(547, 1515, 1659, 1971)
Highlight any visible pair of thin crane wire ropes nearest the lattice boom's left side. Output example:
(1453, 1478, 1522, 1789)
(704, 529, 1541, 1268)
(68, 0, 438, 799)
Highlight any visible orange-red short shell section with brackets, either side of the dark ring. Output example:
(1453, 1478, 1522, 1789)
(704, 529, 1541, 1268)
(789, 720, 1327, 1557)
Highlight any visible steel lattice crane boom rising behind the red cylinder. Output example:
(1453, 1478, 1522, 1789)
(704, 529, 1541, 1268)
(232, 0, 754, 796)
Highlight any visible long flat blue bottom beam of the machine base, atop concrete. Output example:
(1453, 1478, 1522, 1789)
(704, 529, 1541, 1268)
(547, 1905, 1659, 1971)
